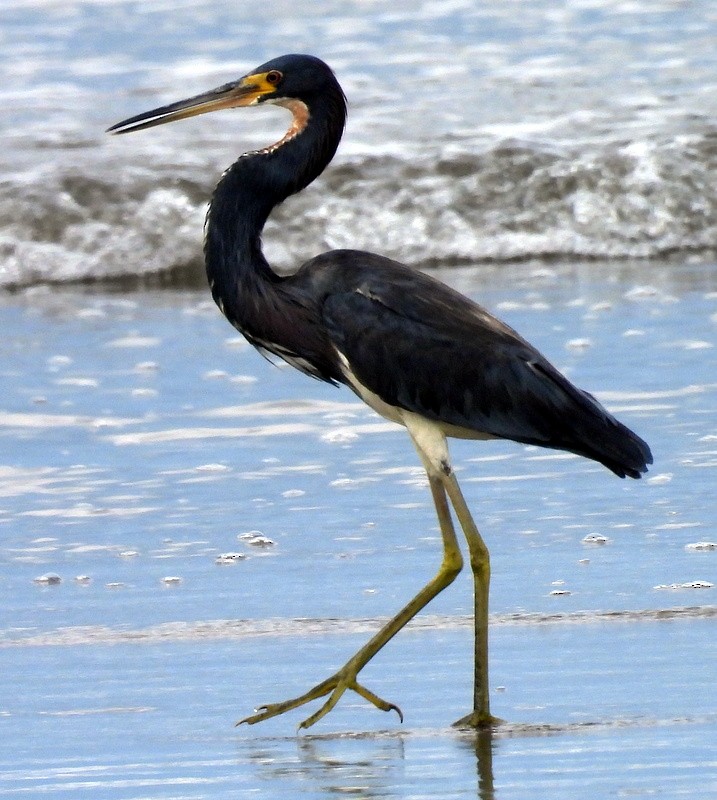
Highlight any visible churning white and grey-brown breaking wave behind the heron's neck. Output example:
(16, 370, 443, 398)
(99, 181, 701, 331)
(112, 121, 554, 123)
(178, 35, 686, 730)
(0, 127, 717, 288)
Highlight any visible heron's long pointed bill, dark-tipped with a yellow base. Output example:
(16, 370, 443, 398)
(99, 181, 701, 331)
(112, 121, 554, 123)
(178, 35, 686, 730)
(107, 73, 275, 134)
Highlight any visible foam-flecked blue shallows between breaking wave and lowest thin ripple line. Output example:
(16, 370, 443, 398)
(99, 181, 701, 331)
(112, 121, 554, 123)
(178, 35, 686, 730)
(0, 265, 717, 629)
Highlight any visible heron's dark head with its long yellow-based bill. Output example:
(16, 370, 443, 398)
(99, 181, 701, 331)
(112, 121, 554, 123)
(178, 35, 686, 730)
(108, 55, 343, 134)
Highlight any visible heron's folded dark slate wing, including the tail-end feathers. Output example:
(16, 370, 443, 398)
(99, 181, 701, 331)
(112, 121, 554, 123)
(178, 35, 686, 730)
(314, 250, 649, 475)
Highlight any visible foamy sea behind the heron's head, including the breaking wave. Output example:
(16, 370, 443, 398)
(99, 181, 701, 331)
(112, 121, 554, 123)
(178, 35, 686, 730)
(0, 0, 717, 286)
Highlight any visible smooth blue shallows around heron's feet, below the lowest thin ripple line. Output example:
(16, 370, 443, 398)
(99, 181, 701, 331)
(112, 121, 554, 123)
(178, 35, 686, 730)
(0, 621, 717, 800)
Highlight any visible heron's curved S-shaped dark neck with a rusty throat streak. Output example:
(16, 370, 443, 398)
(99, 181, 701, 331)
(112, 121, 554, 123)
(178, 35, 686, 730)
(204, 98, 345, 338)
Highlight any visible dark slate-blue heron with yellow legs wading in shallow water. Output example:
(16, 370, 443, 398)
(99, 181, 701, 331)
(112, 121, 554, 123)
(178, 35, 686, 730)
(108, 54, 652, 729)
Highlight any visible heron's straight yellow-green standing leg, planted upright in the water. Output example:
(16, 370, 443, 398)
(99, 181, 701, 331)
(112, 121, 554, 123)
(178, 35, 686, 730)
(443, 470, 501, 728)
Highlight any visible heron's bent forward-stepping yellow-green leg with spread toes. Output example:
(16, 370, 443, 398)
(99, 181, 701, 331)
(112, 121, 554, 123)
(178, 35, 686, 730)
(237, 475, 463, 728)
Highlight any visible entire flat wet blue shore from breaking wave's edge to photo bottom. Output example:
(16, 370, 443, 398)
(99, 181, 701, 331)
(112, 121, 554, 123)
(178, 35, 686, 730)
(0, 262, 717, 800)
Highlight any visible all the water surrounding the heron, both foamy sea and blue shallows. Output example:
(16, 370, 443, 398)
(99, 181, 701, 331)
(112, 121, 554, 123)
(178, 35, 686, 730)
(0, 0, 717, 800)
